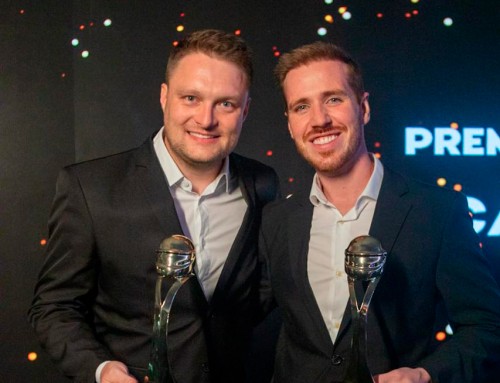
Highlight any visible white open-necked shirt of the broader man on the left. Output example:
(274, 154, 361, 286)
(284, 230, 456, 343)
(153, 128, 247, 301)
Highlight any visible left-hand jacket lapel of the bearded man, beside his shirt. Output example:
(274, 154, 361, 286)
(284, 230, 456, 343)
(287, 195, 332, 355)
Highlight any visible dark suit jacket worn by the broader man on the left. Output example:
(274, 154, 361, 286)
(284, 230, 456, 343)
(29, 139, 278, 383)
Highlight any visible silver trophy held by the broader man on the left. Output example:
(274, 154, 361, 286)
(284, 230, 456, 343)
(144, 235, 195, 383)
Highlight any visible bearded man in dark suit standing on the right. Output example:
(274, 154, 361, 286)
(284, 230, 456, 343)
(259, 42, 500, 383)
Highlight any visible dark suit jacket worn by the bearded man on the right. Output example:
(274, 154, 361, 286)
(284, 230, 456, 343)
(259, 168, 500, 383)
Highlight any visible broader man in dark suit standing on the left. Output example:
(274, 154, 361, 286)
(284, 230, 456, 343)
(29, 30, 278, 383)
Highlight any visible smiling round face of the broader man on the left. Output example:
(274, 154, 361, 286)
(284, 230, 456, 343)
(160, 53, 250, 175)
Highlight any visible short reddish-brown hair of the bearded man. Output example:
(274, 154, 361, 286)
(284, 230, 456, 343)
(274, 41, 365, 100)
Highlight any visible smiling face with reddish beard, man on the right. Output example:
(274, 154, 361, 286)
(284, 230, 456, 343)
(283, 60, 370, 177)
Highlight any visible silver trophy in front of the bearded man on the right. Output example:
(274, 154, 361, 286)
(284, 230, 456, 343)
(344, 235, 387, 383)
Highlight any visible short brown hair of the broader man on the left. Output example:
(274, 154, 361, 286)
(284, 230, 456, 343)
(165, 29, 253, 86)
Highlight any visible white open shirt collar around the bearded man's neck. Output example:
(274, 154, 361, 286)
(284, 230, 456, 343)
(309, 153, 384, 207)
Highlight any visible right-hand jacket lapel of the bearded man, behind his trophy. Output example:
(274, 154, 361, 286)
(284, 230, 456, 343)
(335, 167, 411, 344)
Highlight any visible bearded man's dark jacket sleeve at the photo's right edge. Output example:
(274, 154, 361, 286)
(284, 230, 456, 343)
(422, 194, 500, 383)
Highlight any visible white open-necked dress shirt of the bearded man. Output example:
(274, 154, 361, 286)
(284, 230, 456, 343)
(307, 156, 384, 343)
